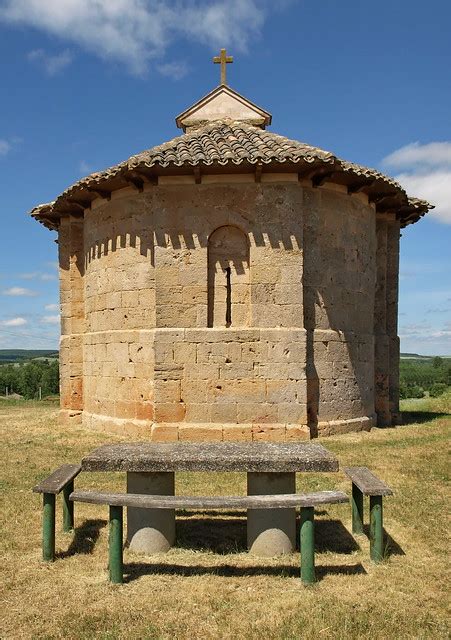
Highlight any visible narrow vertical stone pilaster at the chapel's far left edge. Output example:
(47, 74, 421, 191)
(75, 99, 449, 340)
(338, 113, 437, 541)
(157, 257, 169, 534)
(58, 216, 85, 421)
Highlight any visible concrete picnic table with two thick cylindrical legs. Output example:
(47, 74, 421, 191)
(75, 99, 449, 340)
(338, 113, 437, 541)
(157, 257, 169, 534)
(81, 442, 338, 556)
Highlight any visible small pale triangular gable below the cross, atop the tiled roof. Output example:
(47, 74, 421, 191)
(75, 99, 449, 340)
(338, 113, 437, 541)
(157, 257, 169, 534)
(175, 85, 272, 131)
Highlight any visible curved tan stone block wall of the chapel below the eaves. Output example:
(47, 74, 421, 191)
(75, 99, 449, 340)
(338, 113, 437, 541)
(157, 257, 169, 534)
(60, 174, 395, 440)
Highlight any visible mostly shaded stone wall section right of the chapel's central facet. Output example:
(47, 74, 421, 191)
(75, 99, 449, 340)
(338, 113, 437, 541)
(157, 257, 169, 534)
(303, 185, 376, 435)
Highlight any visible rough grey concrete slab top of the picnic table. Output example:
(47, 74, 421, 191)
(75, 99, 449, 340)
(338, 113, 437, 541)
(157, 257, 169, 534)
(81, 442, 338, 473)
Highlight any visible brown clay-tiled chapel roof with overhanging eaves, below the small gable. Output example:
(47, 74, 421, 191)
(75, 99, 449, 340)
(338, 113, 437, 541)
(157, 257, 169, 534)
(31, 120, 432, 229)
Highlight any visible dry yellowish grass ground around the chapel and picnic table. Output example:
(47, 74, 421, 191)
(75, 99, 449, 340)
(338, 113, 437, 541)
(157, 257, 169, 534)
(0, 394, 451, 640)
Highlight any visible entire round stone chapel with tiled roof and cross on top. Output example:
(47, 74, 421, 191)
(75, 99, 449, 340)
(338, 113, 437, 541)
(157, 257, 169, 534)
(31, 50, 431, 441)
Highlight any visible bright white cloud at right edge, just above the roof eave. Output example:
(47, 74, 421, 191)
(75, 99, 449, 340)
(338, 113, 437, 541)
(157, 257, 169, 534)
(383, 142, 451, 224)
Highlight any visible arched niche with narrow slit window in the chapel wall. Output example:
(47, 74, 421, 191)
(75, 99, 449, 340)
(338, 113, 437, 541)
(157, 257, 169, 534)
(208, 225, 250, 327)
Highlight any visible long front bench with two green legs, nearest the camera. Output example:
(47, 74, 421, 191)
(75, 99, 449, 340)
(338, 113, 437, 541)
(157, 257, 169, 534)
(69, 491, 349, 584)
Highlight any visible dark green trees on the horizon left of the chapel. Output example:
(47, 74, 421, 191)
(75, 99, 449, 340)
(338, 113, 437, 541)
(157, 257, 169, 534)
(0, 360, 59, 399)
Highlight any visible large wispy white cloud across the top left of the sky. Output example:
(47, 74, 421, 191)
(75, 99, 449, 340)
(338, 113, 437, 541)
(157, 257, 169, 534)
(0, 0, 268, 73)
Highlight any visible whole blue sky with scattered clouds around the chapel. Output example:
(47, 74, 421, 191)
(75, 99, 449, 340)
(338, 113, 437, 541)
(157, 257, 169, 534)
(0, 0, 451, 355)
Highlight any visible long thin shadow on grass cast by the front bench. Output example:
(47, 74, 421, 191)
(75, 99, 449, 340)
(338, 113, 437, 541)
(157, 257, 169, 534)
(124, 562, 366, 583)
